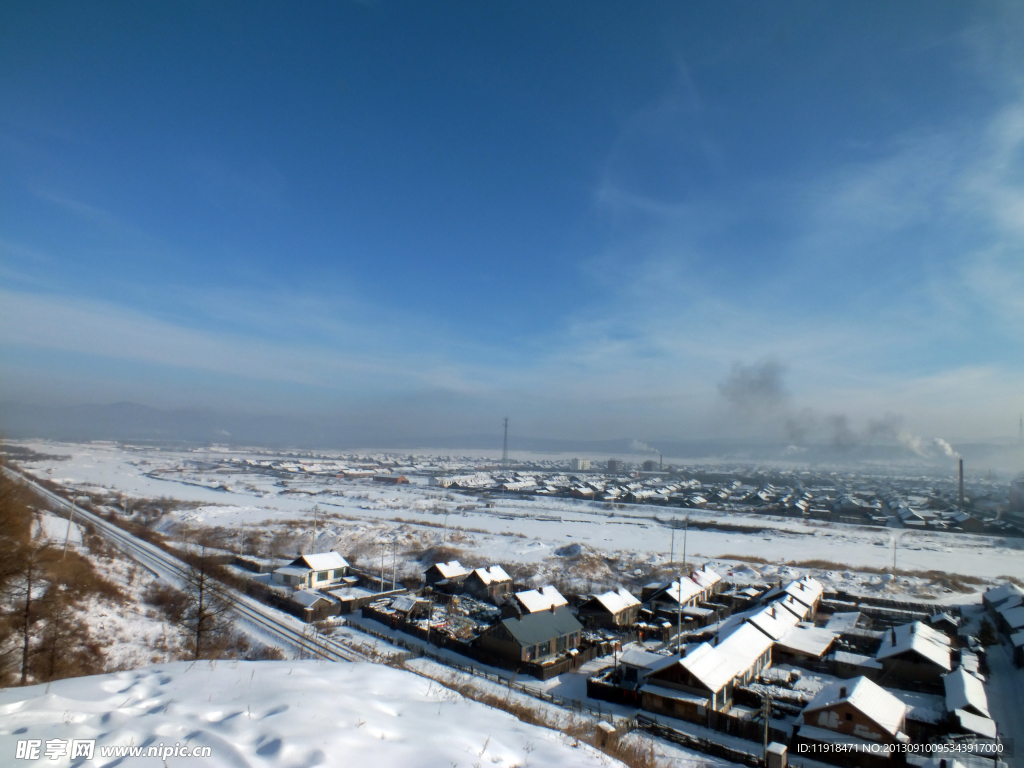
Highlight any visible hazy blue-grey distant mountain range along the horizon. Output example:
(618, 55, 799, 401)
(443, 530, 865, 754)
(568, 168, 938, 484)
(0, 402, 1024, 472)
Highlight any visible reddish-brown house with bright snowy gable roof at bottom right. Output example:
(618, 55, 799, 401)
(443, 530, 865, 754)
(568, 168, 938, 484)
(797, 677, 908, 749)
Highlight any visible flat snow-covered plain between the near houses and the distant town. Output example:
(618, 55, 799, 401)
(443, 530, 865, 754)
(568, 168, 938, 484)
(9, 442, 1024, 602)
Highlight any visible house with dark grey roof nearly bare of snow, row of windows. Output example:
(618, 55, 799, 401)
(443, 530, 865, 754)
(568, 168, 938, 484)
(479, 605, 583, 664)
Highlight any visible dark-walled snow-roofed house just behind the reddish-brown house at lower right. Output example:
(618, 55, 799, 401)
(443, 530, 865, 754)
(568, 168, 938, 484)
(874, 622, 952, 688)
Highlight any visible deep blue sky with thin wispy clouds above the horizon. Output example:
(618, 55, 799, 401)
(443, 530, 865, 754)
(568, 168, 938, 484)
(0, 0, 1024, 439)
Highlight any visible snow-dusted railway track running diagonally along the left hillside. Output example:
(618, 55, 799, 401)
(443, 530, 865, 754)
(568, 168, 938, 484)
(2, 467, 373, 662)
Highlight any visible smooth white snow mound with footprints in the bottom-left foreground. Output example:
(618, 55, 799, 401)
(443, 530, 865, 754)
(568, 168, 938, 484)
(0, 662, 622, 768)
